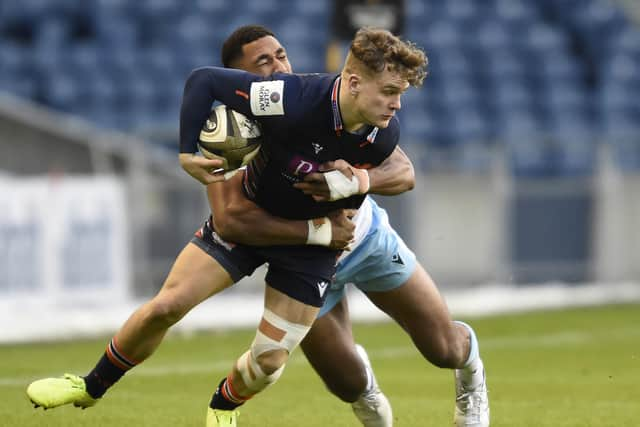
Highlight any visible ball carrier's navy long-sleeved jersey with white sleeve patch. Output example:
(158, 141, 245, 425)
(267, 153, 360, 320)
(180, 67, 400, 219)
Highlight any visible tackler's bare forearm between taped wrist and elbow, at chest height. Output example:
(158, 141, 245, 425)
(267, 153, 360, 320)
(368, 147, 416, 196)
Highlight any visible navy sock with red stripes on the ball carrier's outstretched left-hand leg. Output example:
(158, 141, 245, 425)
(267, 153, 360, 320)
(84, 338, 137, 399)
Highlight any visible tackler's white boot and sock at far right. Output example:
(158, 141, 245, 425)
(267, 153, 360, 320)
(453, 361, 489, 427)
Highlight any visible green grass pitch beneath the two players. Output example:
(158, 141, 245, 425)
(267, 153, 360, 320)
(0, 305, 640, 427)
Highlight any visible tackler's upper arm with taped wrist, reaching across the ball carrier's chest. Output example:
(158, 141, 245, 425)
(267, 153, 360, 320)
(294, 146, 415, 201)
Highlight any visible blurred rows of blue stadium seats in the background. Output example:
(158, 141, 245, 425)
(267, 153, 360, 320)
(0, 0, 640, 176)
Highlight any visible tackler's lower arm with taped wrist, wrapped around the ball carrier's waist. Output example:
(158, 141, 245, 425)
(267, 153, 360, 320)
(207, 173, 355, 249)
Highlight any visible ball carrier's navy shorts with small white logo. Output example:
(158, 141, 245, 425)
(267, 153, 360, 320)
(191, 218, 339, 307)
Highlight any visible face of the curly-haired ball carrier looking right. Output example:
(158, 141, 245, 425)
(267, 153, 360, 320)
(355, 69, 409, 128)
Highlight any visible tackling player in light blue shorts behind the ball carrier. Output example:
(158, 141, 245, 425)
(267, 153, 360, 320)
(208, 26, 489, 427)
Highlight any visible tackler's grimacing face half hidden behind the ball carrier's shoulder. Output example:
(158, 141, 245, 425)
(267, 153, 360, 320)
(233, 36, 291, 76)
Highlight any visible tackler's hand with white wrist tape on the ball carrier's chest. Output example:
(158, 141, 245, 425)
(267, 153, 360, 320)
(293, 159, 369, 202)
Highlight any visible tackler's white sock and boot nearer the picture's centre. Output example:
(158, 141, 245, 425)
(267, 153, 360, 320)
(351, 344, 393, 427)
